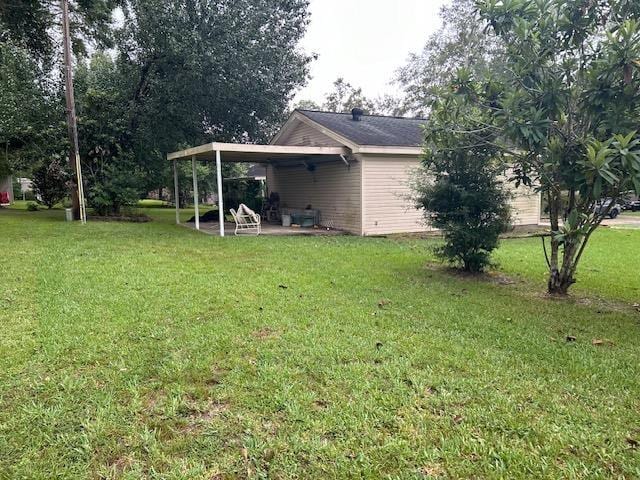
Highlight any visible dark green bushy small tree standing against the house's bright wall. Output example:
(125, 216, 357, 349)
(416, 83, 510, 272)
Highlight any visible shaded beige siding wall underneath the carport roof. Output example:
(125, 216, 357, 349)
(267, 161, 361, 234)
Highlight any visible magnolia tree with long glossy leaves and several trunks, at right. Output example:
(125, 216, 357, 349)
(456, 0, 640, 294)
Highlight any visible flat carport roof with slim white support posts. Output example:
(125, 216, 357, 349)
(167, 142, 350, 237)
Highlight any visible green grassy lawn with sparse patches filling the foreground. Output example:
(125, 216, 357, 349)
(0, 209, 640, 479)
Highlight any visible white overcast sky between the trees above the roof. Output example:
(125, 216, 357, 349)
(296, 0, 447, 102)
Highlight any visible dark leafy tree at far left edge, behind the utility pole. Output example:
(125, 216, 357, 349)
(0, 0, 118, 186)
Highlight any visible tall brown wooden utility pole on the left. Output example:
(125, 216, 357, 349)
(60, 0, 87, 223)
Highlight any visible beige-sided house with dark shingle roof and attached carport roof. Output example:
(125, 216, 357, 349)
(168, 109, 540, 236)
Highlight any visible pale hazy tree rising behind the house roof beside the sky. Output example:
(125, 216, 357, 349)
(395, 0, 503, 117)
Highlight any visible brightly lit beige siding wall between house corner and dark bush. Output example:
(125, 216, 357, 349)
(362, 155, 430, 235)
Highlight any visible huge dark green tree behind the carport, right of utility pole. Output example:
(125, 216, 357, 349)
(66, 0, 310, 214)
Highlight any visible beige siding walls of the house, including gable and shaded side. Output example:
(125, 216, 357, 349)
(267, 121, 540, 235)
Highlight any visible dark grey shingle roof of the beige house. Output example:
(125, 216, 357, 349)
(298, 110, 426, 147)
